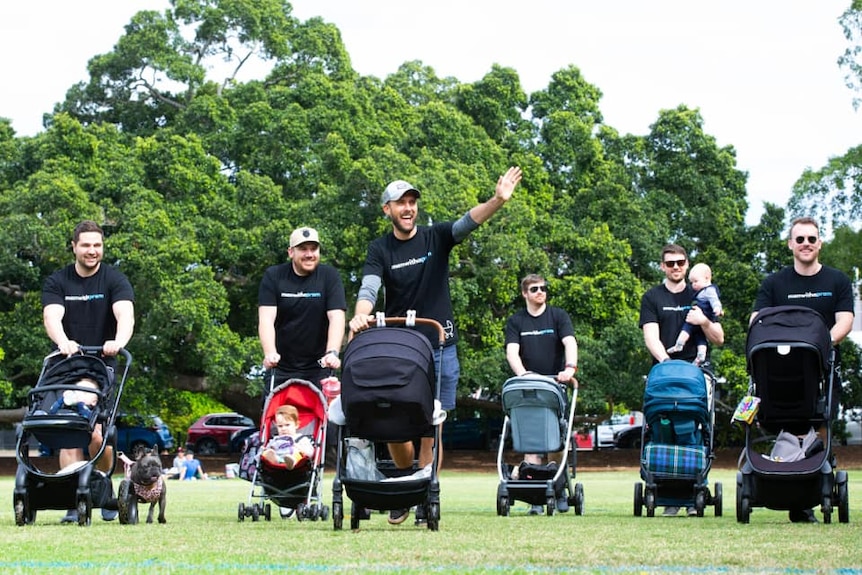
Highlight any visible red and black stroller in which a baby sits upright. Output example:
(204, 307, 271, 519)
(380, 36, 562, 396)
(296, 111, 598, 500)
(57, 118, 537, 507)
(237, 380, 329, 521)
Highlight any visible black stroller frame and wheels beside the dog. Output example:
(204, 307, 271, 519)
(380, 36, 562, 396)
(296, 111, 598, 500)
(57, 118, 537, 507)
(12, 346, 132, 526)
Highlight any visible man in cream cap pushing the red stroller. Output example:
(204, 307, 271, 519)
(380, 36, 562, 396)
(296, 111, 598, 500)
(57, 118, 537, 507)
(257, 227, 347, 394)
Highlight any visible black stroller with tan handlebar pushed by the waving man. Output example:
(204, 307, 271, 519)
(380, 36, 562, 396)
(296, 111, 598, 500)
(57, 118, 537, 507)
(330, 315, 445, 531)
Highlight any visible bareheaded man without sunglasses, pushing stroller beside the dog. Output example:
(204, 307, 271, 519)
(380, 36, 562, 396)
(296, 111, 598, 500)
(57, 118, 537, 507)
(42, 221, 135, 523)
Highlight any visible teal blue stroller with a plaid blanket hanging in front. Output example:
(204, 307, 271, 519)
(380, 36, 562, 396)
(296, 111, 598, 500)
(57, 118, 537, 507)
(634, 360, 722, 517)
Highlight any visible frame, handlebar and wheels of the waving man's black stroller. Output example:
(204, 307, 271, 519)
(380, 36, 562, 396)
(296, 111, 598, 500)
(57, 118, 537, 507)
(332, 316, 446, 531)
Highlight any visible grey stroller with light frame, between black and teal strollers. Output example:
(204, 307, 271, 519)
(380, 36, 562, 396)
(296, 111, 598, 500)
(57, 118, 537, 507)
(497, 374, 584, 516)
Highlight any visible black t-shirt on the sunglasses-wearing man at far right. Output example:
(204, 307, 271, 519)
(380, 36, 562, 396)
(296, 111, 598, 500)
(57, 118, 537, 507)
(754, 266, 853, 329)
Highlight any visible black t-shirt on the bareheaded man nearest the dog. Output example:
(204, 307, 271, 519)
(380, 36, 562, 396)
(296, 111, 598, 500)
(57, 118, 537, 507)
(42, 263, 135, 346)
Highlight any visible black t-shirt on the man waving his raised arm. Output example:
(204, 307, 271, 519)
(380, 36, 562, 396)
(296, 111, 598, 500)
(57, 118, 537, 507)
(362, 222, 458, 348)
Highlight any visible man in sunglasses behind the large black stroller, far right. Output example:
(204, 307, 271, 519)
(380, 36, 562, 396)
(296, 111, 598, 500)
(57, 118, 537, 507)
(750, 217, 853, 523)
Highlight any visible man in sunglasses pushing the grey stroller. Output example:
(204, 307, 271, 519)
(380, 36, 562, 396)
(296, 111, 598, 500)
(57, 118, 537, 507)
(505, 274, 578, 515)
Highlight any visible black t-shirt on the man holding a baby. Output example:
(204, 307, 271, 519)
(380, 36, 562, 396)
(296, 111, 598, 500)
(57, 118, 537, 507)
(638, 283, 697, 363)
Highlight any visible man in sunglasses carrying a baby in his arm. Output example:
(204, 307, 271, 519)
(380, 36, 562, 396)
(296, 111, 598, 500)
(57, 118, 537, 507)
(638, 244, 724, 516)
